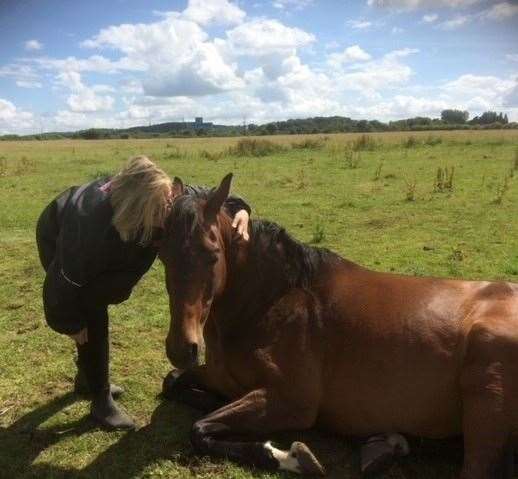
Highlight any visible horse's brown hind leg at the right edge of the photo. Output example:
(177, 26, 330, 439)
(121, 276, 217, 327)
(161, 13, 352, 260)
(461, 324, 513, 479)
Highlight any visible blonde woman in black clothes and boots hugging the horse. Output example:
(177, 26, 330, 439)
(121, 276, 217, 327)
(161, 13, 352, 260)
(36, 156, 250, 429)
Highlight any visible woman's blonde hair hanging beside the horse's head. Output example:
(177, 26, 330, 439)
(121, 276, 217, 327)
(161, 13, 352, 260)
(110, 156, 171, 243)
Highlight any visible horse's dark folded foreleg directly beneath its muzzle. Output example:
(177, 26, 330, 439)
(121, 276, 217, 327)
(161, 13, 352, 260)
(162, 366, 228, 414)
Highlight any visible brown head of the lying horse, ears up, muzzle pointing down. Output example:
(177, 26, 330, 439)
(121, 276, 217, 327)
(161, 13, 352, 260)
(159, 174, 232, 369)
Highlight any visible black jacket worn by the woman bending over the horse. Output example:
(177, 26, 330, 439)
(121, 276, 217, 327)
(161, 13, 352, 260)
(37, 178, 251, 334)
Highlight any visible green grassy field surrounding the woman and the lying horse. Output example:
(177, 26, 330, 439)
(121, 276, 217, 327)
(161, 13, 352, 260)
(0, 131, 518, 479)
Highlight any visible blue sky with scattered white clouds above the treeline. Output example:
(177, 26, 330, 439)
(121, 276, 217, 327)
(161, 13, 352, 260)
(0, 0, 518, 134)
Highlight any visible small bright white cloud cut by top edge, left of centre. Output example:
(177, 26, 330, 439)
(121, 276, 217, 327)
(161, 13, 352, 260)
(182, 0, 246, 25)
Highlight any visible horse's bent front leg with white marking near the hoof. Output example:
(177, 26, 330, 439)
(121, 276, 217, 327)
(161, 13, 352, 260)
(191, 389, 324, 474)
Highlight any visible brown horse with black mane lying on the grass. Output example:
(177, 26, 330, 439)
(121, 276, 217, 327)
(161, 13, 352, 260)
(160, 175, 518, 479)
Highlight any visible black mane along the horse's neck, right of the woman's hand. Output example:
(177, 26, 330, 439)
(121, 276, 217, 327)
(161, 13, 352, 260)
(249, 220, 340, 288)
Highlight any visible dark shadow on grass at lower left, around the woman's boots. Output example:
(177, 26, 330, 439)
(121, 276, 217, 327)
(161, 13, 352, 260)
(0, 393, 199, 479)
